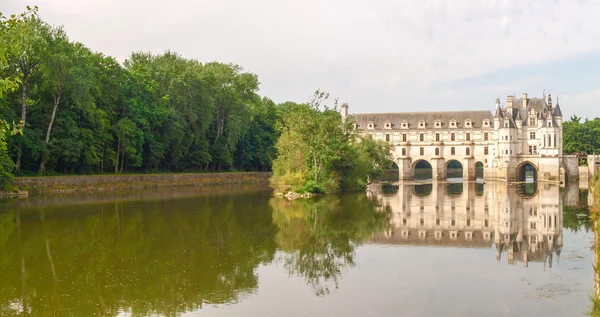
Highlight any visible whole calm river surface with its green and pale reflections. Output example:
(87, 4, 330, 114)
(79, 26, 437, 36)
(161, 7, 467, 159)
(0, 183, 593, 317)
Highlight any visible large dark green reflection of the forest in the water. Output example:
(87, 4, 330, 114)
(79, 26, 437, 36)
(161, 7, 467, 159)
(0, 190, 276, 316)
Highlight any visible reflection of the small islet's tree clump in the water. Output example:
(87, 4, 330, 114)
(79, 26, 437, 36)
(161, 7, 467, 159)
(270, 195, 391, 296)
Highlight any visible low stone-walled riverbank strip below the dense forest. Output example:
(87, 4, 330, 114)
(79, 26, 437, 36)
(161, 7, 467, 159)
(0, 172, 271, 196)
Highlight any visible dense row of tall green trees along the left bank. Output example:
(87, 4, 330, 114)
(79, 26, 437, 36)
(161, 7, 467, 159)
(0, 8, 281, 175)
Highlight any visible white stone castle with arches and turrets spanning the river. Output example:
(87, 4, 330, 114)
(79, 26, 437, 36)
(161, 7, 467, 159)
(341, 93, 579, 182)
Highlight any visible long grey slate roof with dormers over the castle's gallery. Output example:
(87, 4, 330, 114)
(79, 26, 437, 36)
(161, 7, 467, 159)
(352, 110, 494, 130)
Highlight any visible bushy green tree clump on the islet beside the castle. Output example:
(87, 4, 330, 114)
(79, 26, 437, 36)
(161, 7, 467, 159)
(271, 91, 390, 193)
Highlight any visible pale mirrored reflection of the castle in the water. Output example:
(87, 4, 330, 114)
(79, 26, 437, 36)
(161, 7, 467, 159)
(368, 182, 579, 267)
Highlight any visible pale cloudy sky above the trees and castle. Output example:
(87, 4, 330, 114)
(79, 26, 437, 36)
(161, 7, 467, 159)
(0, 0, 600, 120)
